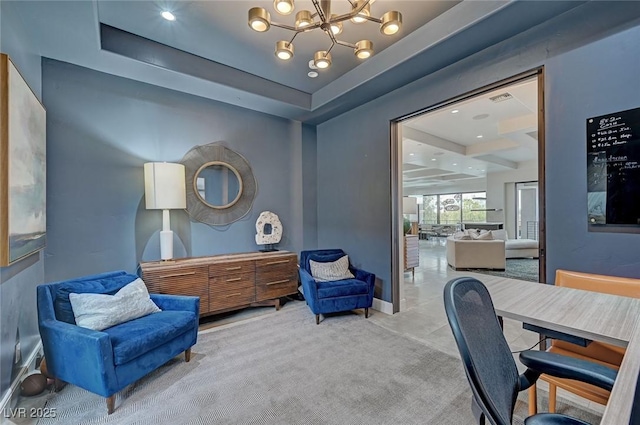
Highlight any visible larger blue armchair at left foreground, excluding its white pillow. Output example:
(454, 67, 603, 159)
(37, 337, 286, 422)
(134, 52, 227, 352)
(37, 271, 200, 414)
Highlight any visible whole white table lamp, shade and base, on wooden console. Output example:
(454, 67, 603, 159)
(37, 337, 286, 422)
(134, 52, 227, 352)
(144, 162, 187, 260)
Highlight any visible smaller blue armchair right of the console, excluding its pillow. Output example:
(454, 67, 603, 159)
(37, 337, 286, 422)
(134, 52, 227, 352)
(299, 249, 376, 324)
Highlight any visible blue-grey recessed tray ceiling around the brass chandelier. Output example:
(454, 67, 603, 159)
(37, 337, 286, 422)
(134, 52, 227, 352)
(11, 0, 584, 124)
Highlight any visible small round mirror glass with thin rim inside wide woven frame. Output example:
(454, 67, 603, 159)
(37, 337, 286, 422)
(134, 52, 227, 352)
(193, 161, 242, 209)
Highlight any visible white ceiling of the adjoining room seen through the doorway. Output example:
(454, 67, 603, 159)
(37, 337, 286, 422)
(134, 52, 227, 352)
(402, 77, 538, 193)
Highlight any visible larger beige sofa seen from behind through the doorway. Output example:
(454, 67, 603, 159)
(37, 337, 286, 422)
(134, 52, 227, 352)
(447, 235, 507, 270)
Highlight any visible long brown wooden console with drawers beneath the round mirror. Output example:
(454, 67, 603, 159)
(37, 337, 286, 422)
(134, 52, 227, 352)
(140, 251, 298, 316)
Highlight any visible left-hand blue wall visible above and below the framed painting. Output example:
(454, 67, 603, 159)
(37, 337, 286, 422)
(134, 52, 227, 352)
(0, 2, 44, 399)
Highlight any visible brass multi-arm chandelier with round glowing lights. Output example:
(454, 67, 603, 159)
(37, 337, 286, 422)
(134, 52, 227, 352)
(249, 0, 402, 69)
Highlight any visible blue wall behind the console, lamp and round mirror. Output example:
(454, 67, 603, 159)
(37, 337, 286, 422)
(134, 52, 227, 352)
(43, 59, 303, 281)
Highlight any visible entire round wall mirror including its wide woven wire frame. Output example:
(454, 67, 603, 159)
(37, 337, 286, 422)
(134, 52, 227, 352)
(181, 142, 258, 226)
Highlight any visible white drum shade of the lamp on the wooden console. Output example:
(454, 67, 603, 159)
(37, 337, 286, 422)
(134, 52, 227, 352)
(144, 162, 187, 210)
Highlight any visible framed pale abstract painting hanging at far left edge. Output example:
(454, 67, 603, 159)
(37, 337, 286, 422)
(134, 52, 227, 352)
(0, 54, 47, 266)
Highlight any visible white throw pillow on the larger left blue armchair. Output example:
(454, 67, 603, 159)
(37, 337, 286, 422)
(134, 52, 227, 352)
(69, 278, 161, 331)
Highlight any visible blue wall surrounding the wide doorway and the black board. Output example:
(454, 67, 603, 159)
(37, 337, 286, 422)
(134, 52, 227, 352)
(317, 2, 640, 301)
